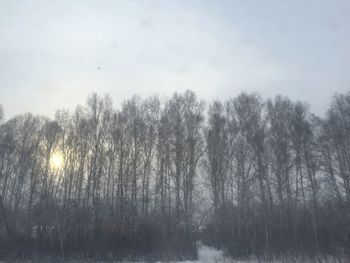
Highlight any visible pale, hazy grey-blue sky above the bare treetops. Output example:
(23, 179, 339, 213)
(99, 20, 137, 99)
(0, 0, 350, 118)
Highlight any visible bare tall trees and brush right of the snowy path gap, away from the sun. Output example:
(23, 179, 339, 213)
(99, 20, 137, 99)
(203, 93, 350, 257)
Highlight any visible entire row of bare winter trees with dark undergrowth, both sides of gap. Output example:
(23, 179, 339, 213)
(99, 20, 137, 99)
(0, 91, 350, 261)
